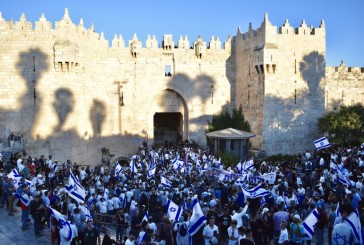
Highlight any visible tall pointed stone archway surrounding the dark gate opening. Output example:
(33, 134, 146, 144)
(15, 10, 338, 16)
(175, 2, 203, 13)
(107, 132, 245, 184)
(148, 89, 188, 144)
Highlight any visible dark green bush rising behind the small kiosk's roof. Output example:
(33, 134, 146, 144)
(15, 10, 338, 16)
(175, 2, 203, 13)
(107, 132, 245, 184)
(206, 106, 251, 133)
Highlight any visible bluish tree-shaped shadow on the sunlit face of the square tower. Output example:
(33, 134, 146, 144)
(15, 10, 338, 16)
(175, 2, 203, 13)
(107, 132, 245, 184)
(264, 51, 326, 153)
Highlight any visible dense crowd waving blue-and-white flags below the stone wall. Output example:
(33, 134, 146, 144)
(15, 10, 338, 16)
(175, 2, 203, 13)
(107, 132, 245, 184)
(0, 140, 364, 245)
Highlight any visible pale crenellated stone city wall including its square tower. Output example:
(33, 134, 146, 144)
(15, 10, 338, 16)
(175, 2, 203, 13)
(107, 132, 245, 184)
(0, 10, 364, 164)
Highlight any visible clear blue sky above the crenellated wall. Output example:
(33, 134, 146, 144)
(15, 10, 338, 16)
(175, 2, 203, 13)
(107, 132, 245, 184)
(0, 0, 364, 67)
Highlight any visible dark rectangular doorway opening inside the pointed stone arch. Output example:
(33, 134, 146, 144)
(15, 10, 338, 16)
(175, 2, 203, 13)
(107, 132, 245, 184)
(153, 112, 183, 145)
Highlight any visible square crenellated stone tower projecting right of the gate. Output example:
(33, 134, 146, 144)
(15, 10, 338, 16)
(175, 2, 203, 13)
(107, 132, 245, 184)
(232, 14, 326, 154)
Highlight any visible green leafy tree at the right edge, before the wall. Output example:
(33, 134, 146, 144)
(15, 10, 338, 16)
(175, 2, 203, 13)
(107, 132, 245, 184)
(318, 104, 364, 145)
